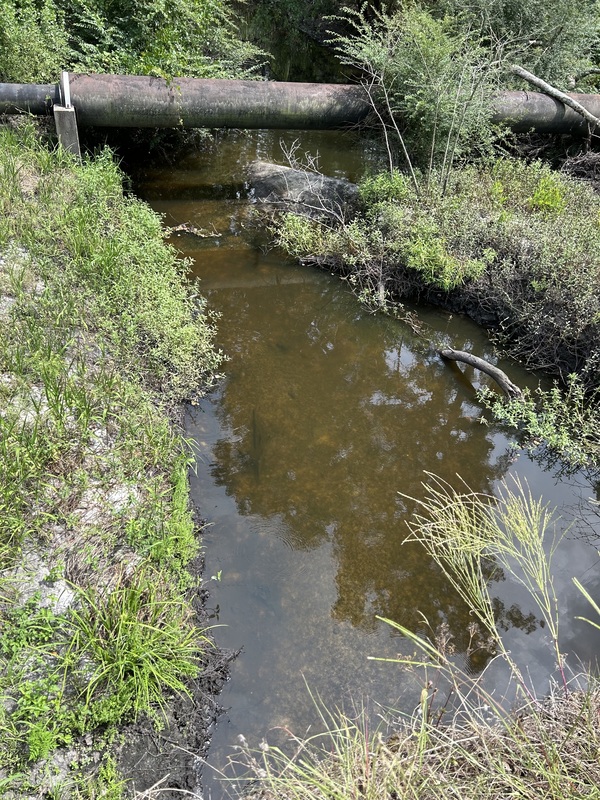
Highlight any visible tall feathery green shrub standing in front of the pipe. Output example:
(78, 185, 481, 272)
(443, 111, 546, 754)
(331, 3, 498, 178)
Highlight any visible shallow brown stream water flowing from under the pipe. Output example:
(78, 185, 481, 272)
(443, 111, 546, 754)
(139, 132, 600, 797)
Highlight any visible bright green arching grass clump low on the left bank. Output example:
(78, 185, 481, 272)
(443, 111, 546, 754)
(69, 570, 208, 724)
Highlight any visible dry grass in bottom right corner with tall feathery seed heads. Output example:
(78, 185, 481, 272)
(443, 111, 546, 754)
(232, 475, 600, 800)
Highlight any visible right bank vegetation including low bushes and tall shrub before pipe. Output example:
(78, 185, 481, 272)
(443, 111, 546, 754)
(275, 2, 600, 471)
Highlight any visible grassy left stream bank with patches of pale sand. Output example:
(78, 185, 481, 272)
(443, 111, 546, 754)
(0, 115, 221, 800)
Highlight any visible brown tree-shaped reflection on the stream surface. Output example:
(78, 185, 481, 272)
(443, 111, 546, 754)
(203, 276, 520, 648)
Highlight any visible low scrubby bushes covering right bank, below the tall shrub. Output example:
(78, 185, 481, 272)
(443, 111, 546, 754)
(277, 157, 600, 468)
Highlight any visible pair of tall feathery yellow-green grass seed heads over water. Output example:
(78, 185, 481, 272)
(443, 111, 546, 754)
(398, 475, 568, 697)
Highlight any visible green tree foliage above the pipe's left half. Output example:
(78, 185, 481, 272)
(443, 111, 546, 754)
(0, 0, 261, 82)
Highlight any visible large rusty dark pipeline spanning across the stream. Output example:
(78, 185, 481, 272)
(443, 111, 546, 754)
(0, 73, 600, 134)
